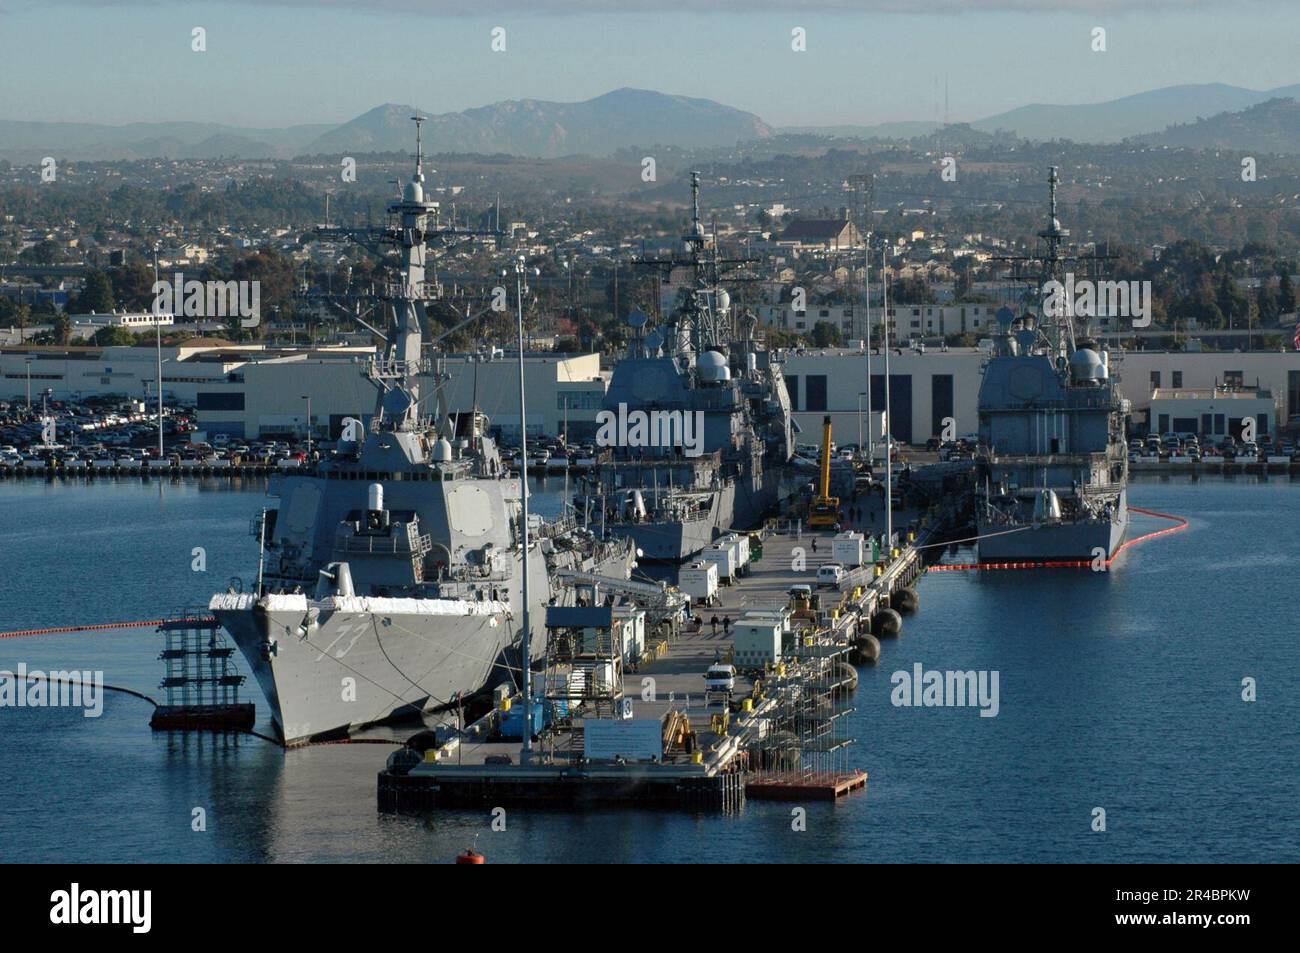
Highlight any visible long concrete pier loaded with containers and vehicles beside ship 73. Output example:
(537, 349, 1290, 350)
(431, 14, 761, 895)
(378, 504, 943, 813)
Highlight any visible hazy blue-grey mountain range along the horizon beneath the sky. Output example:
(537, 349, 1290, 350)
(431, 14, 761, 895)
(0, 83, 1300, 163)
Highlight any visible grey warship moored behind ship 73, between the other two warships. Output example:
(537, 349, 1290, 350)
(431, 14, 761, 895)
(577, 173, 794, 563)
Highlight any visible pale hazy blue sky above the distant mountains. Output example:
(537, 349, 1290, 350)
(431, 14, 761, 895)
(0, 0, 1300, 126)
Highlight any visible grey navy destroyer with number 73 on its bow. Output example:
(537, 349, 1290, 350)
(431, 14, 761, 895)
(209, 120, 633, 745)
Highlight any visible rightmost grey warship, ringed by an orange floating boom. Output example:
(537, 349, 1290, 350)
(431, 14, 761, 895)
(975, 168, 1128, 563)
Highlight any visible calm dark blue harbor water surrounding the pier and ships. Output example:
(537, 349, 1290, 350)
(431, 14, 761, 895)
(0, 477, 1300, 862)
